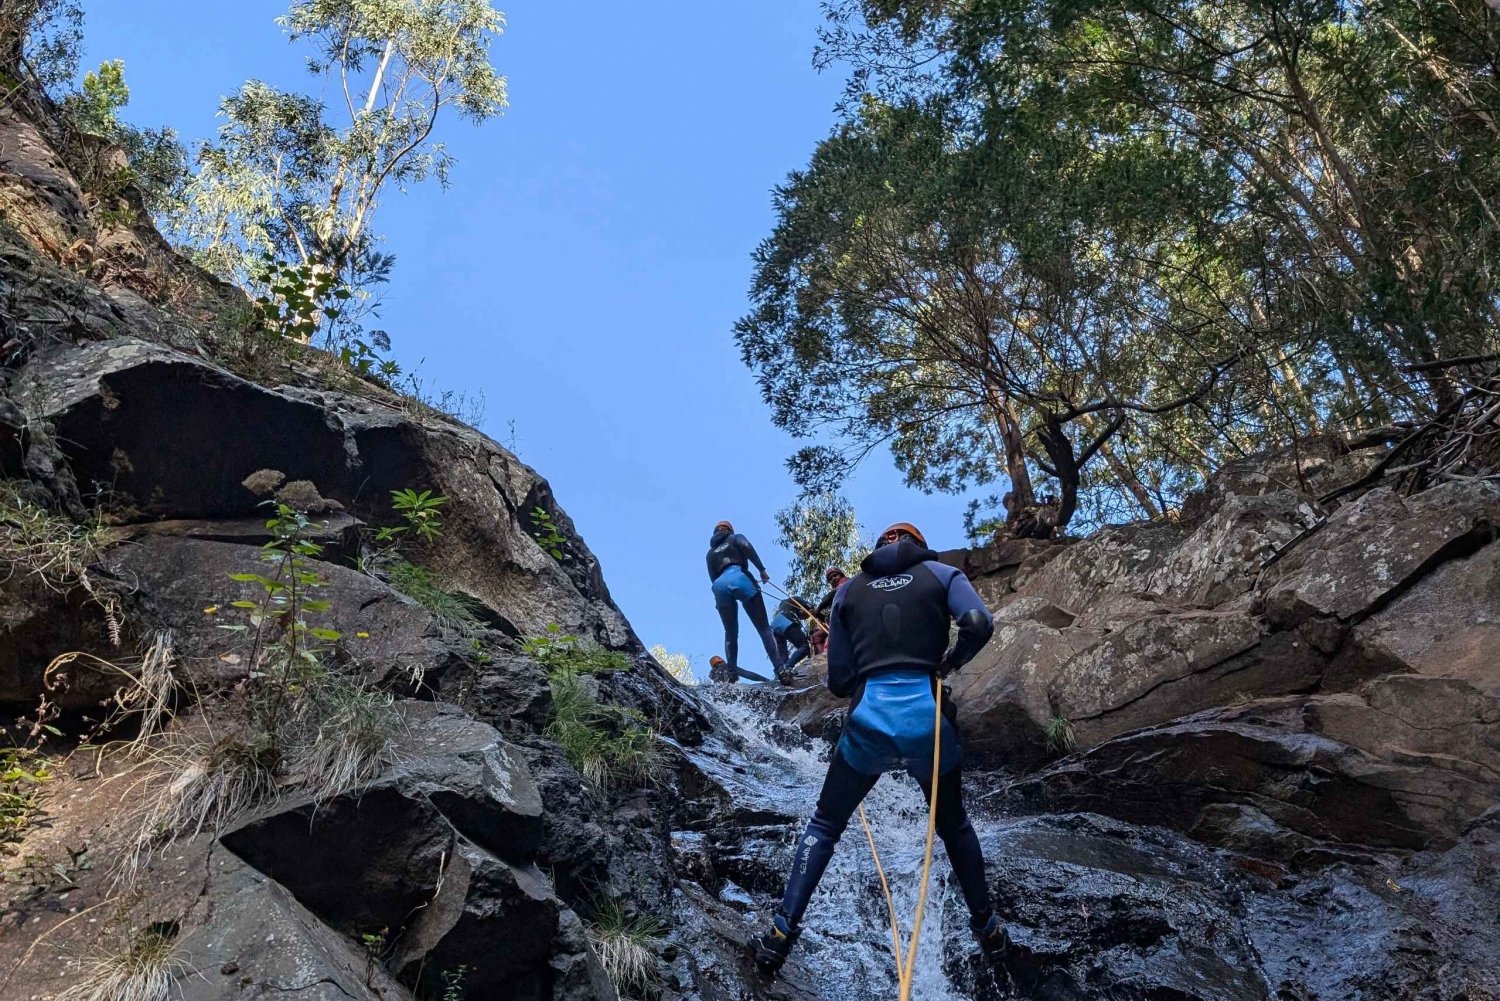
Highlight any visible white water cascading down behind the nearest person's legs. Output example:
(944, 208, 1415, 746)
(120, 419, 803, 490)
(690, 686, 974, 1001)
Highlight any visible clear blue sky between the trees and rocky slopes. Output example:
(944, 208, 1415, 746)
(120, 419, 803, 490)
(84, 0, 963, 674)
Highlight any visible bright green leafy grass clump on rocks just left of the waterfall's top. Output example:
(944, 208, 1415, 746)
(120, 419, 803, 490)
(534, 623, 665, 789)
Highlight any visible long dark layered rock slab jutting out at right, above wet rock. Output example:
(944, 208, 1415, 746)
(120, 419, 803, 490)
(1008, 690, 1500, 858)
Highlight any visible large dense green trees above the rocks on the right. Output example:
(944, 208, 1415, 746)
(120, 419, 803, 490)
(737, 0, 1500, 525)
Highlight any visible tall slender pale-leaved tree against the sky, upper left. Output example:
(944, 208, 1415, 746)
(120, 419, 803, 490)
(174, 0, 506, 347)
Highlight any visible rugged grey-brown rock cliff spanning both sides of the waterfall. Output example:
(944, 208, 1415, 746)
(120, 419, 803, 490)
(0, 74, 1500, 1001)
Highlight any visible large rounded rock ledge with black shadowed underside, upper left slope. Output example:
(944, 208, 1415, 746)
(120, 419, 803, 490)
(18, 338, 635, 647)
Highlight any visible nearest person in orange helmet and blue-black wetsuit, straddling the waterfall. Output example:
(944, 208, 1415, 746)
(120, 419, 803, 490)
(752, 522, 1010, 974)
